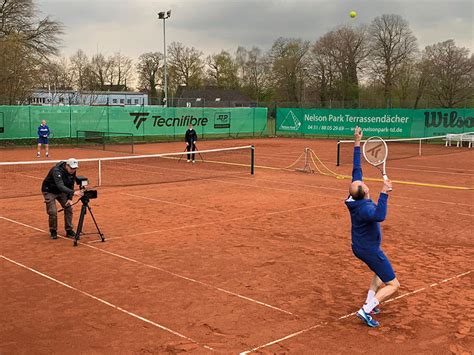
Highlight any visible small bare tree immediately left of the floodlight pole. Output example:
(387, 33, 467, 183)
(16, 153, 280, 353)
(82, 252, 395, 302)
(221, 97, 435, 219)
(137, 52, 163, 104)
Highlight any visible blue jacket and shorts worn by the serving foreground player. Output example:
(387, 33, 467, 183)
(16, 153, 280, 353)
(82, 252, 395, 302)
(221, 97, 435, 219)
(345, 147, 395, 282)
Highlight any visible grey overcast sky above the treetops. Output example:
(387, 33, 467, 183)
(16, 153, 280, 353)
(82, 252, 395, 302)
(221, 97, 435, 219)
(36, 0, 474, 59)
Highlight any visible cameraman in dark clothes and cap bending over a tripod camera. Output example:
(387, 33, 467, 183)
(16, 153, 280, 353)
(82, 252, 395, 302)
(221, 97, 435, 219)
(41, 158, 83, 239)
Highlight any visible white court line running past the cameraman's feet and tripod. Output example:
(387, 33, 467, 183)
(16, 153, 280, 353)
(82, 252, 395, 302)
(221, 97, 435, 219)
(0, 216, 297, 317)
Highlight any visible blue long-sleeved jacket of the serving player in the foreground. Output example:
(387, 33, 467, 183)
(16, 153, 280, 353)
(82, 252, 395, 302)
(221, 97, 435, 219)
(345, 147, 388, 250)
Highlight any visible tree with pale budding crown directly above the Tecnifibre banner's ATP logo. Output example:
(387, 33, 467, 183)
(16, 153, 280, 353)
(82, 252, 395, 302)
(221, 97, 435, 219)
(207, 51, 239, 89)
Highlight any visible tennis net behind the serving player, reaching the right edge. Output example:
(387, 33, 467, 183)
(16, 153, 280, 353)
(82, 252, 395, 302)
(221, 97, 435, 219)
(336, 132, 474, 166)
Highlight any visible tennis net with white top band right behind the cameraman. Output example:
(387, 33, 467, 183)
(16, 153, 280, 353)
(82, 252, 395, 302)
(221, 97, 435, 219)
(0, 146, 255, 199)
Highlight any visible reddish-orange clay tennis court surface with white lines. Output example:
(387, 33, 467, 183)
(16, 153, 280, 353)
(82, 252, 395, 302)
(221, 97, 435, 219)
(0, 138, 474, 354)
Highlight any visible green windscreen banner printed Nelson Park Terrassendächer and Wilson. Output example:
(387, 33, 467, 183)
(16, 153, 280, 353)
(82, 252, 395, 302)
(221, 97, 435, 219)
(276, 108, 474, 138)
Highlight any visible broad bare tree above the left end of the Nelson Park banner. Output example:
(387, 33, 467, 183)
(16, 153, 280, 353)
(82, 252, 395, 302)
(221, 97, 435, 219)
(269, 37, 309, 102)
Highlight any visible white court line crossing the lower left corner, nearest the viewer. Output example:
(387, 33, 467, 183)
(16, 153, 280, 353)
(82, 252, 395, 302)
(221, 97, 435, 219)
(0, 255, 214, 351)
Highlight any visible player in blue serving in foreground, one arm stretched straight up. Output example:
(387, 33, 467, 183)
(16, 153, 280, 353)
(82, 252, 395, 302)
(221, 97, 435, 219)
(345, 127, 400, 327)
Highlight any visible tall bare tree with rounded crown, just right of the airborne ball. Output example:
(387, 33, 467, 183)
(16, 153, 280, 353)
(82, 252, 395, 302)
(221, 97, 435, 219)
(369, 15, 418, 105)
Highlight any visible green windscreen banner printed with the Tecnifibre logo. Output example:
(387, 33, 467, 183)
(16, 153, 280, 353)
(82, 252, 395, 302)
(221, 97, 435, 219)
(0, 106, 268, 139)
